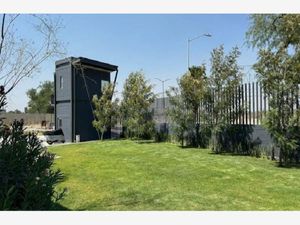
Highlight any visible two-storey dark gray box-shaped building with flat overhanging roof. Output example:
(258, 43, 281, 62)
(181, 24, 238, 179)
(54, 57, 118, 142)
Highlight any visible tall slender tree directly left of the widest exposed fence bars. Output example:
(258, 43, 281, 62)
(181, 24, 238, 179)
(209, 46, 243, 153)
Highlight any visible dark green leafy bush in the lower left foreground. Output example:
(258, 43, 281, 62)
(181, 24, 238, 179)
(0, 121, 65, 210)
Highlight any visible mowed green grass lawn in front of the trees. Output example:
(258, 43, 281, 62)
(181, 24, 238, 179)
(50, 140, 300, 210)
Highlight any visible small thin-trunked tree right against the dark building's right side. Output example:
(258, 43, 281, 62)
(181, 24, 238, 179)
(92, 84, 119, 141)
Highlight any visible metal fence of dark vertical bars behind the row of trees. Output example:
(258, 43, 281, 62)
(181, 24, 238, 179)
(150, 82, 300, 125)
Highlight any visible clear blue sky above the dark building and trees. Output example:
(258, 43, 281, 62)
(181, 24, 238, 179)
(7, 14, 256, 111)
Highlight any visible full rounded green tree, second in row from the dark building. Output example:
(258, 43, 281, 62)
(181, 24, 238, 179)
(121, 72, 155, 138)
